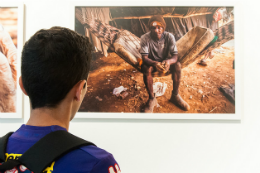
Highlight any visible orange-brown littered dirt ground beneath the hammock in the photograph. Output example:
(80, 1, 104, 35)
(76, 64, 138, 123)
(79, 46, 235, 113)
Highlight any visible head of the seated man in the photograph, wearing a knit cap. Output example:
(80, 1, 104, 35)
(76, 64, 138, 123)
(148, 15, 166, 40)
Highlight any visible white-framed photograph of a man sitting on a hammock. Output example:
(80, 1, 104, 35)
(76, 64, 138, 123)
(71, 3, 242, 120)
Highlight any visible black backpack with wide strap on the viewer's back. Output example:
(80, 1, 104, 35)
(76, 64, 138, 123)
(0, 130, 95, 173)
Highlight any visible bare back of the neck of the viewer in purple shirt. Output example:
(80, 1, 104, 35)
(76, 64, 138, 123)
(26, 104, 71, 130)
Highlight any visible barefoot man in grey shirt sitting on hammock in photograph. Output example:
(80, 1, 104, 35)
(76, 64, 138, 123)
(140, 15, 190, 113)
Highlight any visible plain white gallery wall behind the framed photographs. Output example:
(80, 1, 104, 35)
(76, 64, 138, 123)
(0, 0, 260, 173)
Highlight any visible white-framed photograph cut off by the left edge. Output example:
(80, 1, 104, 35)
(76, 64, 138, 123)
(0, 1, 24, 118)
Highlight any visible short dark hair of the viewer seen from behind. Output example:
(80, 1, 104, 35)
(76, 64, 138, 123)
(21, 27, 91, 109)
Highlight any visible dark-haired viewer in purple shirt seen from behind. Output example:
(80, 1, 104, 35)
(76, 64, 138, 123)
(0, 27, 120, 173)
